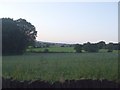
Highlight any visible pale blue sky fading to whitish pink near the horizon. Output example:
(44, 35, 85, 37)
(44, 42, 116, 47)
(0, 1, 118, 43)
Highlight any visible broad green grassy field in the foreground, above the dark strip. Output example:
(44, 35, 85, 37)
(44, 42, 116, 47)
(2, 53, 118, 82)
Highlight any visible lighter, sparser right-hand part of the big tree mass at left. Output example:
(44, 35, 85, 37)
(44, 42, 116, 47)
(16, 18, 37, 46)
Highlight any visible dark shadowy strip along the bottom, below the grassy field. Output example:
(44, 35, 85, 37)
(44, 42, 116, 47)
(2, 78, 120, 89)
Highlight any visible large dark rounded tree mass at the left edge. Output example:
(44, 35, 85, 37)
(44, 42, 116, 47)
(2, 18, 37, 55)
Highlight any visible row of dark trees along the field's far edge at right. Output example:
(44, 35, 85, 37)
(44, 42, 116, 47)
(74, 41, 120, 53)
